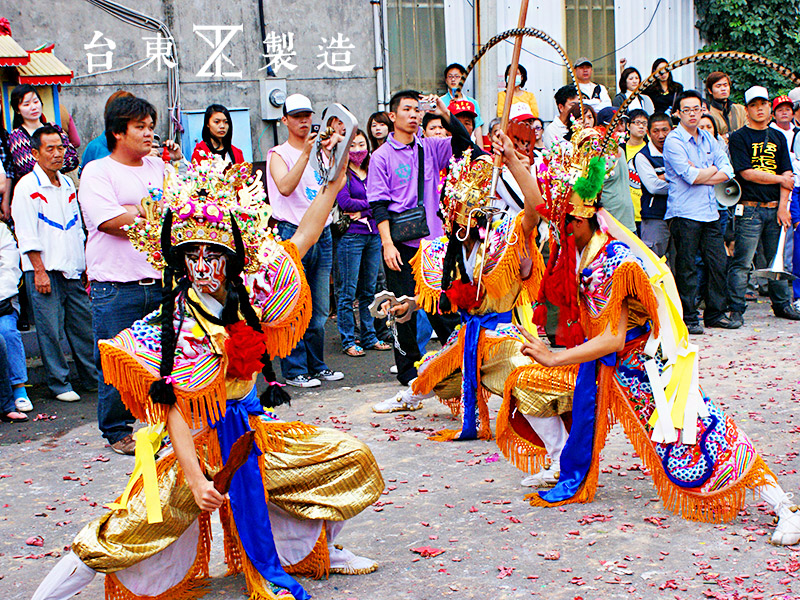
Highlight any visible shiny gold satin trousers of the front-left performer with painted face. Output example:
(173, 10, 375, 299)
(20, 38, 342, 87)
(72, 417, 384, 573)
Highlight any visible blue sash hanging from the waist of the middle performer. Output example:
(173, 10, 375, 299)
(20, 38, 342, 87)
(455, 310, 511, 440)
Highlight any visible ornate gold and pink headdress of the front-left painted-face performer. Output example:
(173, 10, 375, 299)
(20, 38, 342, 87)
(126, 161, 274, 273)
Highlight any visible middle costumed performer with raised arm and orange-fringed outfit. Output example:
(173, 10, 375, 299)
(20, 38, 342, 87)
(393, 132, 574, 482)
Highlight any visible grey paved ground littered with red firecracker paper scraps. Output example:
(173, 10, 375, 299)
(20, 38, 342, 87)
(0, 304, 800, 600)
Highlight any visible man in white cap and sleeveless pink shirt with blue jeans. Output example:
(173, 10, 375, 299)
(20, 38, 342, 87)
(267, 94, 344, 387)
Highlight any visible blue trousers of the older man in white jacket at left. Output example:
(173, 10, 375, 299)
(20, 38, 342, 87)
(25, 271, 97, 396)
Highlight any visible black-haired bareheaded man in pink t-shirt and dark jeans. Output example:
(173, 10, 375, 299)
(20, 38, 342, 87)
(79, 98, 181, 455)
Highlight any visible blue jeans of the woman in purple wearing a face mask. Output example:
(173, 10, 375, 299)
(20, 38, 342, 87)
(336, 233, 381, 350)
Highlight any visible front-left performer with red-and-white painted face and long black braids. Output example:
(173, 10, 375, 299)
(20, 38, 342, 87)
(34, 161, 383, 600)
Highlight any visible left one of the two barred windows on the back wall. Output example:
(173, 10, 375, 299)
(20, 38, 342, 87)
(384, 0, 447, 94)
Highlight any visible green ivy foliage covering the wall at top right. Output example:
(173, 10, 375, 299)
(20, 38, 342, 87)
(695, 0, 800, 102)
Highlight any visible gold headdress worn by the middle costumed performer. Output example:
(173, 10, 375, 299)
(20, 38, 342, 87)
(440, 149, 492, 235)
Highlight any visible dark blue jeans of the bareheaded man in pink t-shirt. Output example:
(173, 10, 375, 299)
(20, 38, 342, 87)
(91, 281, 161, 444)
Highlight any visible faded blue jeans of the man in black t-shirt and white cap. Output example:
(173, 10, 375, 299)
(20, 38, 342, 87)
(728, 206, 791, 313)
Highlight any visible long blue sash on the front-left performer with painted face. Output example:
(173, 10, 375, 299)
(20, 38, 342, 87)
(213, 386, 311, 600)
